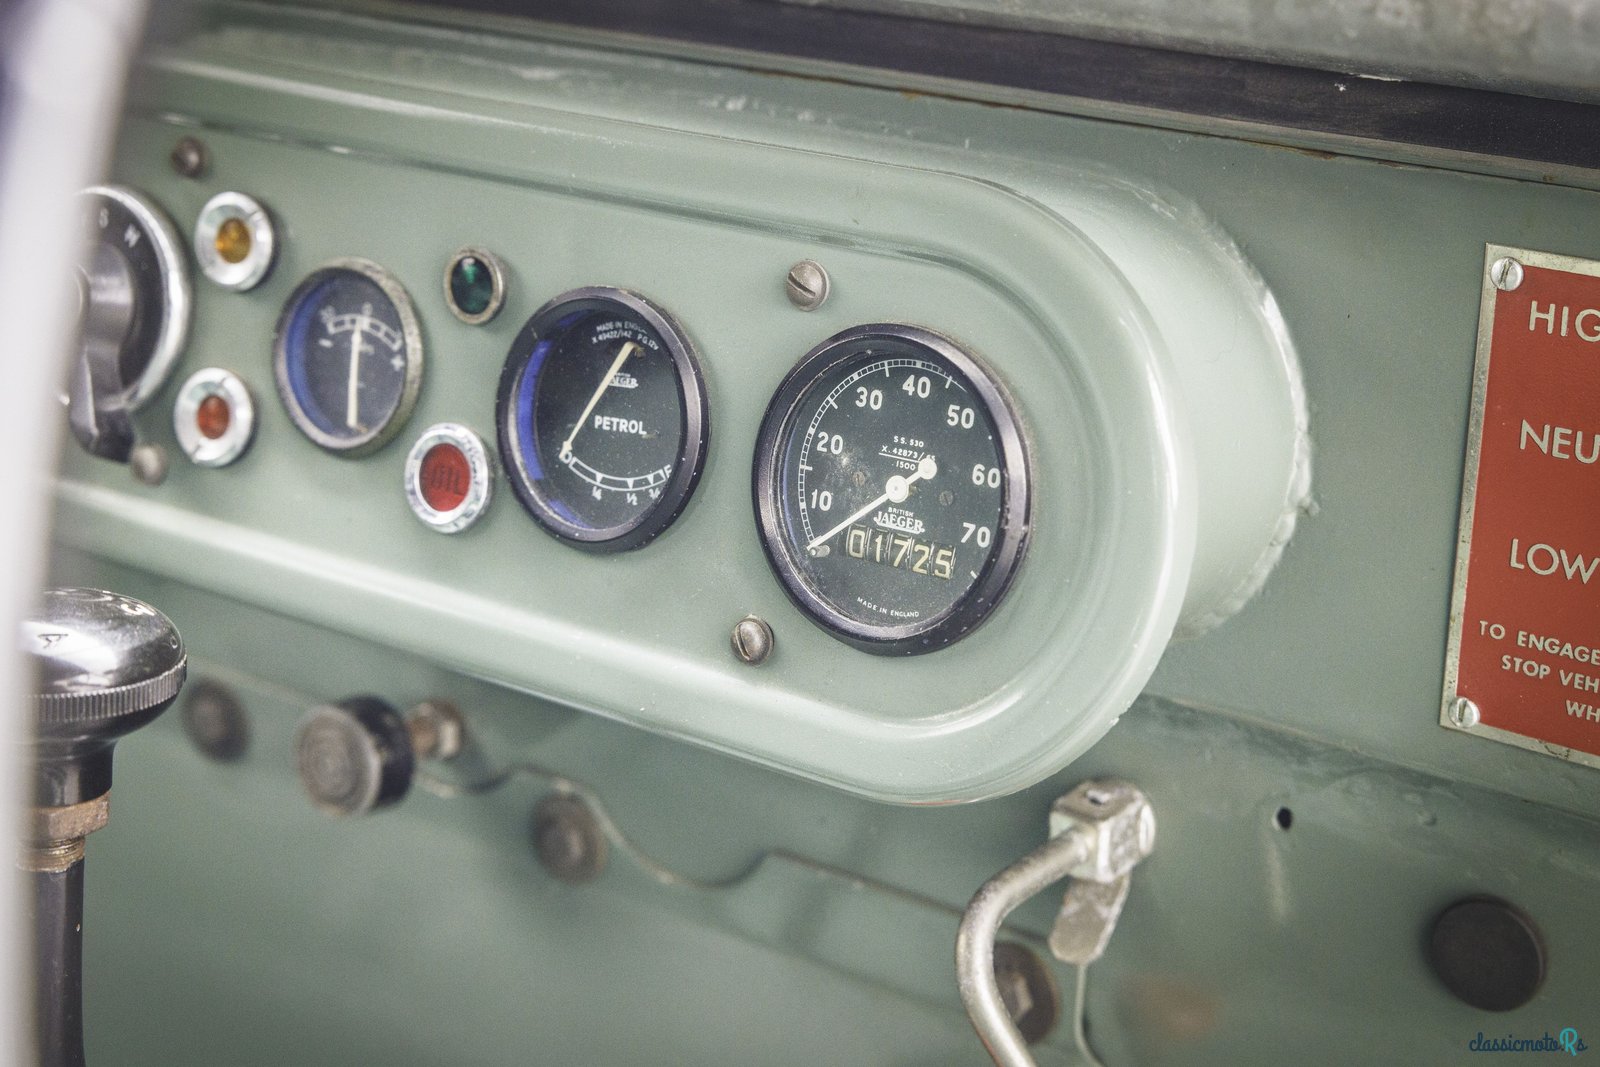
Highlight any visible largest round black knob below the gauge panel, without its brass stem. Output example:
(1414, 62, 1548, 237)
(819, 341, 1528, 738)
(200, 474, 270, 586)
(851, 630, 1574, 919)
(294, 696, 416, 816)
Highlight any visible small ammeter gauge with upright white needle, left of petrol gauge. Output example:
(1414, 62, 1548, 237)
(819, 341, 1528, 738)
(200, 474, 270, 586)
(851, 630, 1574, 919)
(275, 259, 422, 454)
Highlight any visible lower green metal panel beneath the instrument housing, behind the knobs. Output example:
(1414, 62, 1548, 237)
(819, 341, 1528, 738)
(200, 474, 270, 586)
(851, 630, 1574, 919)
(62, 558, 1600, 1065)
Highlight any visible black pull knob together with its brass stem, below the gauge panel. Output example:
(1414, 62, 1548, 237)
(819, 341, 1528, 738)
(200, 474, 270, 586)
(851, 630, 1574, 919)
(294, 696, 462, 816)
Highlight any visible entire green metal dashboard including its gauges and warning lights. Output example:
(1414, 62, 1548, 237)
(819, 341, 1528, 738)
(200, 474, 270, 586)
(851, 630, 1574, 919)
(25, 3, 1600, 1064)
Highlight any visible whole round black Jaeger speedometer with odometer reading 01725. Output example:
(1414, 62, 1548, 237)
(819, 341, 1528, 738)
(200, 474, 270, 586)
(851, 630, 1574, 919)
(755, 325, 1029, 654)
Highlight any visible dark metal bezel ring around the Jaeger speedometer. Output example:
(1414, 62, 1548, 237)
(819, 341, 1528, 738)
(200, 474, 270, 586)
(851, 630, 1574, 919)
(752, 323, 1032, 656)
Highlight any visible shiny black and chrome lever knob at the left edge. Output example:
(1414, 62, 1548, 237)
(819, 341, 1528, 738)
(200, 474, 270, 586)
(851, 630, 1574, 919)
(22, 589, 187, 808)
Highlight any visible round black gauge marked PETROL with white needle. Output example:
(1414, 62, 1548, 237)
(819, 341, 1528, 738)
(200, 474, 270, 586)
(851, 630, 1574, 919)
(498, 288, 707, 550)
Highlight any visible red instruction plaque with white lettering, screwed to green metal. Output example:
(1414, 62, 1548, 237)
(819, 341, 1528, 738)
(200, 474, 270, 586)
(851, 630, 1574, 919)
(1440, 245, 1600, 766)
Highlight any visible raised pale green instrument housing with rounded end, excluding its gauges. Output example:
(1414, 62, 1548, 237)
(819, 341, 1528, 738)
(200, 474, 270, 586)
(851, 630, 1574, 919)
(62, 0, 1302, 803)
